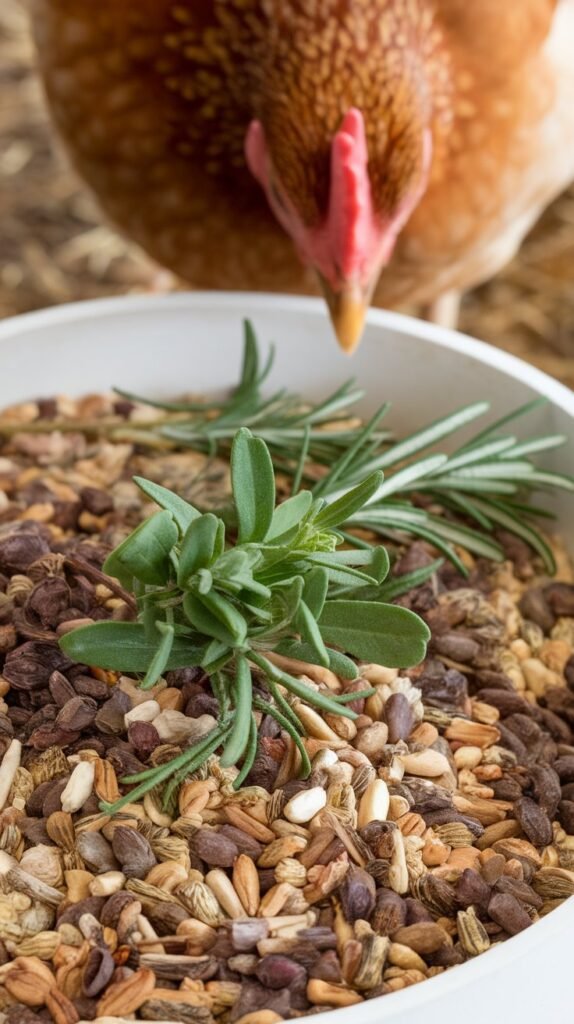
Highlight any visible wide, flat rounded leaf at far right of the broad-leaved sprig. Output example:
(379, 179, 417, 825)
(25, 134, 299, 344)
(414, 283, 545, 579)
(319, 601, 431, 669)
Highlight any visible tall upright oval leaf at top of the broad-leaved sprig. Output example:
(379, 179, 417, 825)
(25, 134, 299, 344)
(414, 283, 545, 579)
(231, 427, 275, 544)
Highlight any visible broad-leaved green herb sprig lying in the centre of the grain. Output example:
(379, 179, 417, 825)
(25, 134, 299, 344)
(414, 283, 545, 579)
(60, 428, 429, 813)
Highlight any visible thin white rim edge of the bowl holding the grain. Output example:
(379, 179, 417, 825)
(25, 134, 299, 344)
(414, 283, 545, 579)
(0, 292, 574, 1024)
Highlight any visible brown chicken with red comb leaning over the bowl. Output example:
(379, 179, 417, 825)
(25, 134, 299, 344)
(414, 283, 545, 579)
(33, 0, 574, 350)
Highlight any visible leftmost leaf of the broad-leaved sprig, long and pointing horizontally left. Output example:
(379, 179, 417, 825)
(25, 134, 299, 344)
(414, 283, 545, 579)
(59, 622, 206, 672)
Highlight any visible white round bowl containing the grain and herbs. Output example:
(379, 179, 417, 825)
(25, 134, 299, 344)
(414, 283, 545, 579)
(0, 293, 574, 1024)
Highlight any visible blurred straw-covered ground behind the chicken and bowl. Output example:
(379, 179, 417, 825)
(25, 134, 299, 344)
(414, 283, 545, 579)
(0, 0, 574, 387)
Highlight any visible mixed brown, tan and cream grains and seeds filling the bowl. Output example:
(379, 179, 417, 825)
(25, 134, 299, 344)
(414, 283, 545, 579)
(0, 387, 574, 1024)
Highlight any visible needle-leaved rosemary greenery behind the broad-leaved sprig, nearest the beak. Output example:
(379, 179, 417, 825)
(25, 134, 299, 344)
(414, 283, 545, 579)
(115, 322, 574, 575)
